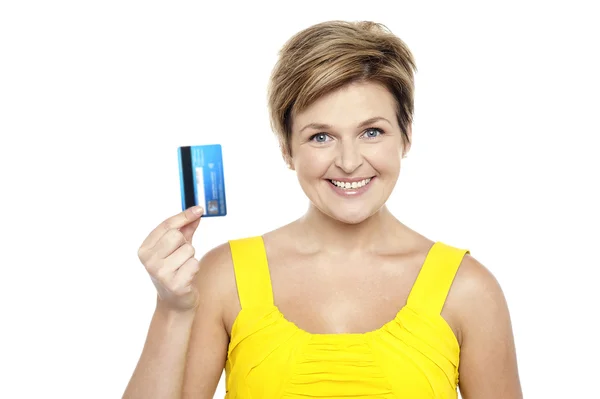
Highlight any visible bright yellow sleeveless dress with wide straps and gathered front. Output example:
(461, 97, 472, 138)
(225, 236, 469, 399)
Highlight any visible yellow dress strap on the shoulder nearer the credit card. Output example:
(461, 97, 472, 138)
(229, 236, 273, 308)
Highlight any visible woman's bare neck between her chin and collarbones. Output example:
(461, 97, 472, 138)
(299, 204, 402, 253)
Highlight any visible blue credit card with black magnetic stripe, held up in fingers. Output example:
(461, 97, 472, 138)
(177, 144, 227, 217)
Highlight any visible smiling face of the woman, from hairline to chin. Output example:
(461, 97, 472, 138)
(290, 82, 409, 224)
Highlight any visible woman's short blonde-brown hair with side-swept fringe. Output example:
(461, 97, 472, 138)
(268, 21, 416, 162)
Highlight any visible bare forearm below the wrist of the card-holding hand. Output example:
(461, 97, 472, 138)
(123, 304, 194, 399)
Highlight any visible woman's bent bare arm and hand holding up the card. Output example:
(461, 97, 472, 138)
(123, 209, 228, 399)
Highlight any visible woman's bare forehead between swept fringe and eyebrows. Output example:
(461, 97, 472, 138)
(292, 82, 396, 130)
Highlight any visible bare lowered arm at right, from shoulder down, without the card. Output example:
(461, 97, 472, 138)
(447, 254, 522, 399)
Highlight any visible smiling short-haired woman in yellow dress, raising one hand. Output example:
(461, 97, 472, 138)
(124, 21, 522, 399)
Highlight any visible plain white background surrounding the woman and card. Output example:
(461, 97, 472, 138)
(0, 0, 600, 399)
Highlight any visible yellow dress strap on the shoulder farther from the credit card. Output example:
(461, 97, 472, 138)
(407, 242, 470, 314)
